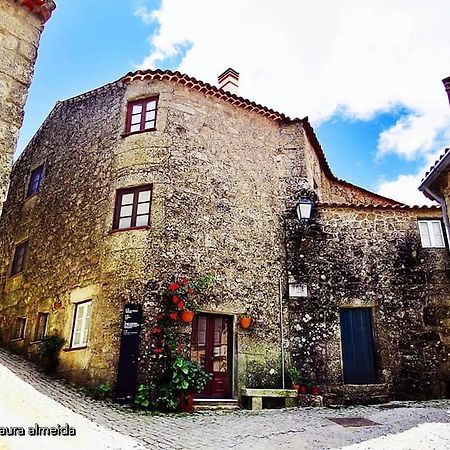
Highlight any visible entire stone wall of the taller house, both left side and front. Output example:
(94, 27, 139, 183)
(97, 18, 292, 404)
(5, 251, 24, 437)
(0, 81, 310, 394)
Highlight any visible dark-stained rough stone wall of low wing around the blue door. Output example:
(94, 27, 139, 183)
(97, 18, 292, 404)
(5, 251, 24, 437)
(289, 206, 450, 399)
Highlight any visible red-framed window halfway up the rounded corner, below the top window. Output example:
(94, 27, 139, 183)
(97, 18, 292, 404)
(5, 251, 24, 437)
(113, 185, 152, 230)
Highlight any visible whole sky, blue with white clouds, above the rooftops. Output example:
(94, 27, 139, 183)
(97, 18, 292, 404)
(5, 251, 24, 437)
(19, 0, 450, 203)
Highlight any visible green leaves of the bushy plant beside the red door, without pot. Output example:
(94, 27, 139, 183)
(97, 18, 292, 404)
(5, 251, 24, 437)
(172, 356, 212, 392)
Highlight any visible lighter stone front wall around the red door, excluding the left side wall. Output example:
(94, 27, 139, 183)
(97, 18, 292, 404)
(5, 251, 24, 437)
(103, 82, 302, 385)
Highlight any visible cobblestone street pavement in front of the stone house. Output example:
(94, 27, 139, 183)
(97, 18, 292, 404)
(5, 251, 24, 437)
(0, 349, 450, 450)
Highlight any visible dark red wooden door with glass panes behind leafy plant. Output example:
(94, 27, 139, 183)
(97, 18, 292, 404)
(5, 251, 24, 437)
(191, 314, 233, 398)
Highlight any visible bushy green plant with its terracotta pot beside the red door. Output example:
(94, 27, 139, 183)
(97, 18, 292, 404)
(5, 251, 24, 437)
(172, 356, 212, 412)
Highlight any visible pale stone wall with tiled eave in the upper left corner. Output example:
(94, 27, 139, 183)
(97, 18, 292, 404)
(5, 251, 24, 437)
(0, 0, 55, 209)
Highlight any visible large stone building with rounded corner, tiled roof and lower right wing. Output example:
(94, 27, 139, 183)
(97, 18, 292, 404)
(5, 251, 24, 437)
(0, 70, 449, 401)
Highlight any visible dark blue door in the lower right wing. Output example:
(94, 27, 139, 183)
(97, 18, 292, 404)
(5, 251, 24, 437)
(341, 308, 378, 384)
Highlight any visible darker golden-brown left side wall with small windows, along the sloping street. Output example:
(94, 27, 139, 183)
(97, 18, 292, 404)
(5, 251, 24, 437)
(0, 83, 123, 381)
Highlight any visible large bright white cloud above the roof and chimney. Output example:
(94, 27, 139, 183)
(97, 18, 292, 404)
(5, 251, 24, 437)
(135, 0, 450, 202)
